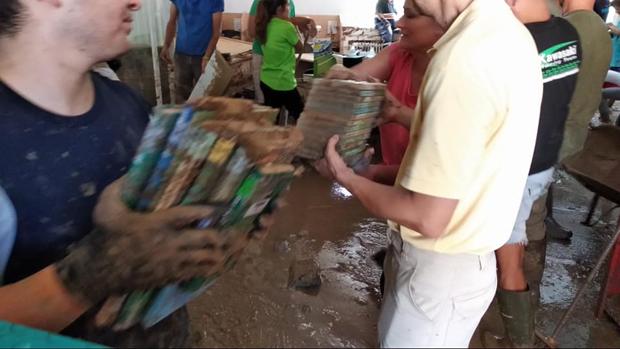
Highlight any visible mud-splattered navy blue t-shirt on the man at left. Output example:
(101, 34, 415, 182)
(0, 73, 150, 283)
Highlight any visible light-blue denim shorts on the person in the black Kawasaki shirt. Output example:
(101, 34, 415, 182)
(506, 167, 555, 245)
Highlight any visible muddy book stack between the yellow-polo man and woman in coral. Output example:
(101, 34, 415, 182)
(297, 79, 385, 166)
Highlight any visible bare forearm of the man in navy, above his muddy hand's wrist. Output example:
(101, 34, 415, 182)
(0, 266, 90, 332)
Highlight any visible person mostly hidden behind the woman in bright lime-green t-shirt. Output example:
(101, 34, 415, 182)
(248, 0, 316, 104)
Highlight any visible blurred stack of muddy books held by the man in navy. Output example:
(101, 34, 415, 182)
(96, 97, 303, 330)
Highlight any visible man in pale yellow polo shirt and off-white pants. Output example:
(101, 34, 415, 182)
(316, 0, 543, 347)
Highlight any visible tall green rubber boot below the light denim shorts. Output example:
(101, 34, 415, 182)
(497, 289, 536, 348)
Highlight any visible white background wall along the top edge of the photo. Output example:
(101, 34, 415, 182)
(225, 0, 405, 27)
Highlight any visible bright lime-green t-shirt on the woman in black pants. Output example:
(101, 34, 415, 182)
(260, 18, 299, 91)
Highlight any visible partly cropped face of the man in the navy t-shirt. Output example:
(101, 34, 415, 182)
(56, 0, 141, 60)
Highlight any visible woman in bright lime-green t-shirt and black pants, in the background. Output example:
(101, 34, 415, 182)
(256, 0, 304, 120)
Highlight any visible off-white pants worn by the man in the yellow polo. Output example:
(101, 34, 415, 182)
(379, 231, 497, 348)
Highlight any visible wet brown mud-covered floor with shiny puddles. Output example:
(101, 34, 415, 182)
(190, 171, 620, 347)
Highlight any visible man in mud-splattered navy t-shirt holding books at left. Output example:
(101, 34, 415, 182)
(0, 0, 268, 347)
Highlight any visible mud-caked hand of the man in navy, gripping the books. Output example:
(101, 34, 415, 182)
(56, 179, 230, 303)
